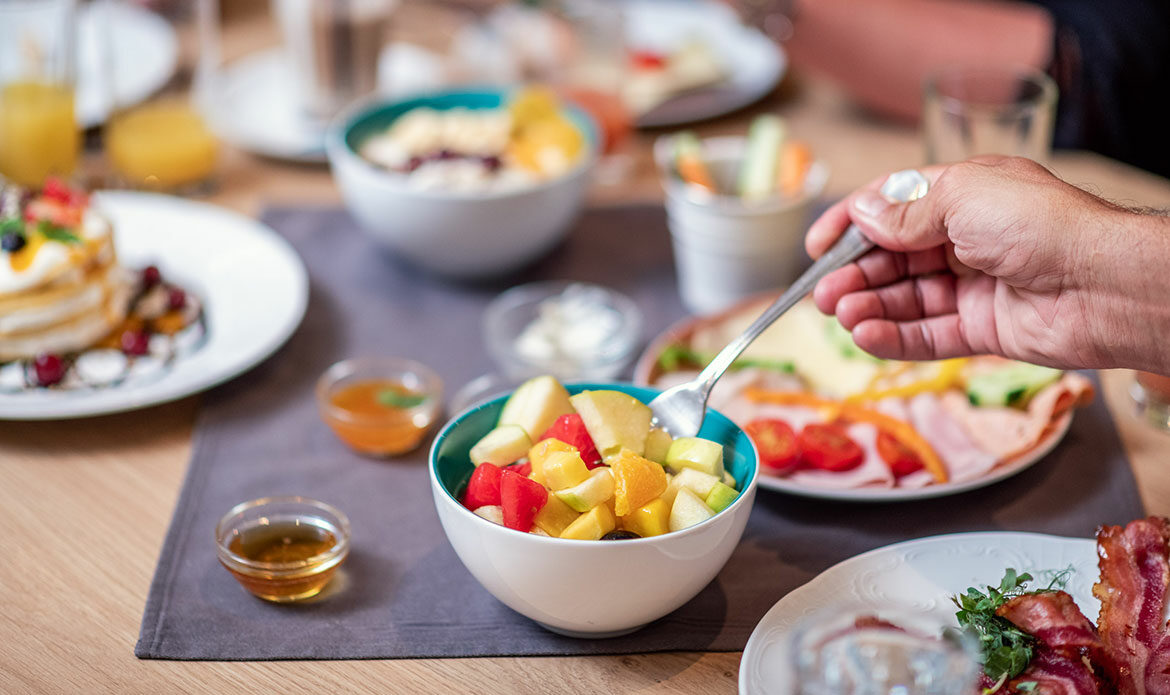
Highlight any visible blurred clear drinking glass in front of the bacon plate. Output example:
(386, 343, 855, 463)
(791, 606, 978, 695)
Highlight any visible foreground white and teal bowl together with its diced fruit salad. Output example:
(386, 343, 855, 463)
(431, 377, 757, 636)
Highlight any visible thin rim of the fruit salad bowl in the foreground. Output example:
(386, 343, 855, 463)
(427, 381, 759, 549)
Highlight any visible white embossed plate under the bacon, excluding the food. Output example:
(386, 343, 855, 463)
(739, 532, 1101, 695)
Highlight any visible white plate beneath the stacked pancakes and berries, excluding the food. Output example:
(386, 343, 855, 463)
(0, 192, 309, 420)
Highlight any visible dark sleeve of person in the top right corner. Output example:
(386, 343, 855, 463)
(1032, 0, 1170, 174)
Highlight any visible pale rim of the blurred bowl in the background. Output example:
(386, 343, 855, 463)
(325, 85, 600, 201)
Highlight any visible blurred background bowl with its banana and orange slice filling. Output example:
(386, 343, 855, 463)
(326, 89, 598, 277)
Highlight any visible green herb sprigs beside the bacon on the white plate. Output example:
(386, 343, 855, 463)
(951, 566, 1073, 693)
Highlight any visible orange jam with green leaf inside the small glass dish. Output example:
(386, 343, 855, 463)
(322, 379, 435, 456)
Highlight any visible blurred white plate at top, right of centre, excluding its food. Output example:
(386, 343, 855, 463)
(622, 0, 787, 128)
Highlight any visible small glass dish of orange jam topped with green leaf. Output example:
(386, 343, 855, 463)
(316, 357, 442, 456)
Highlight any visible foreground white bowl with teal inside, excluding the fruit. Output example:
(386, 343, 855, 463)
(429, 384, 758, 638)
